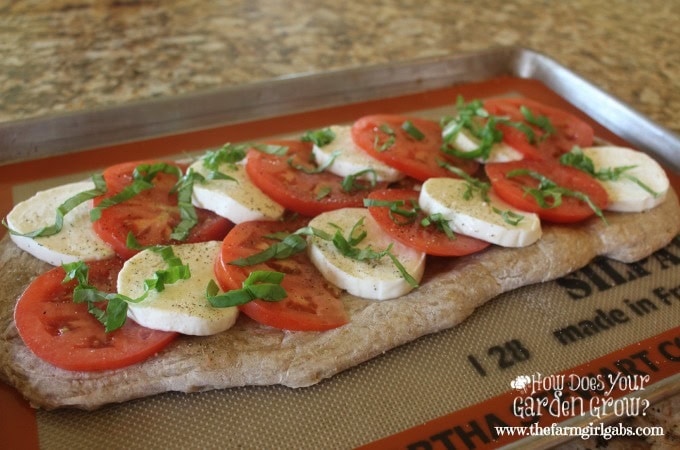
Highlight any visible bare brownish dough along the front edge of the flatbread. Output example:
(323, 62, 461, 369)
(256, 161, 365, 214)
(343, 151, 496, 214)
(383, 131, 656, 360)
(0, 190, 680, 409)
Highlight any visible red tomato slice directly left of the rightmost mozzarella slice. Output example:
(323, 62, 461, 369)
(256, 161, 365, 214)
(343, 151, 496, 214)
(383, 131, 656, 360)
(485, 161, 608, 223)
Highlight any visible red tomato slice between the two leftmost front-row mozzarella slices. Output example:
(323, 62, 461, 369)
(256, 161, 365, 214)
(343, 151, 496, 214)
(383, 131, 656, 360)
(215, 221, 348, 331)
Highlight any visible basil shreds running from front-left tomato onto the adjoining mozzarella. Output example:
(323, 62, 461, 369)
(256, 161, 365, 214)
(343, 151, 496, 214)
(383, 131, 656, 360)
(62, 244, 191, 333)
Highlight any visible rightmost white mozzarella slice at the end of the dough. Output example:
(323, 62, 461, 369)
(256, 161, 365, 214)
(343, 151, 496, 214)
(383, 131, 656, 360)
(582, 146, 670, 212)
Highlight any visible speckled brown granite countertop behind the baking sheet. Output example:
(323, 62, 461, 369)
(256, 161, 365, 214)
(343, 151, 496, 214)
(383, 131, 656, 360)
(0, 0, 680, 448)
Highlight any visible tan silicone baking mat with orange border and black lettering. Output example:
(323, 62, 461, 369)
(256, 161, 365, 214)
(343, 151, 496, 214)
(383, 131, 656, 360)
(0, 77, 680, 448)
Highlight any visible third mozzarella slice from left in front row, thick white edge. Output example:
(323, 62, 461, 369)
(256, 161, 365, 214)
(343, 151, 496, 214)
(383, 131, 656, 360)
(418, 178, 541, 247)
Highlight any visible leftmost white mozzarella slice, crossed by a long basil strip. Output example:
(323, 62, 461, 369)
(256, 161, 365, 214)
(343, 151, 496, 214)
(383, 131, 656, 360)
(7, 181, 114, 266)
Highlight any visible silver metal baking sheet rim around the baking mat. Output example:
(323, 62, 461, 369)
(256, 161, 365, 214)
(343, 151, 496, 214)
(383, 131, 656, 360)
(0, 48, 680, 448)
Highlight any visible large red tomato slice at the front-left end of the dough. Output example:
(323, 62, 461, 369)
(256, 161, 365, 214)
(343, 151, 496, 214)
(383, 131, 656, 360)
(14, 258, 176, 371)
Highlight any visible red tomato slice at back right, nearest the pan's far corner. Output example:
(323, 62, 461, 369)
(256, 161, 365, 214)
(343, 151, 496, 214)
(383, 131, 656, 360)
(484, 98, 594, 159)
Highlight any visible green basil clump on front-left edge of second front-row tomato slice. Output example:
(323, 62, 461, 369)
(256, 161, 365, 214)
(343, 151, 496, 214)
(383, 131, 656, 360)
(206, 270, 288, 308)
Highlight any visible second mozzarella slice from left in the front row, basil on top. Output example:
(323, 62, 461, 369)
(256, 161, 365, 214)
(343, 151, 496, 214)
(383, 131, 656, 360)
(307, 208, 425, 300)
